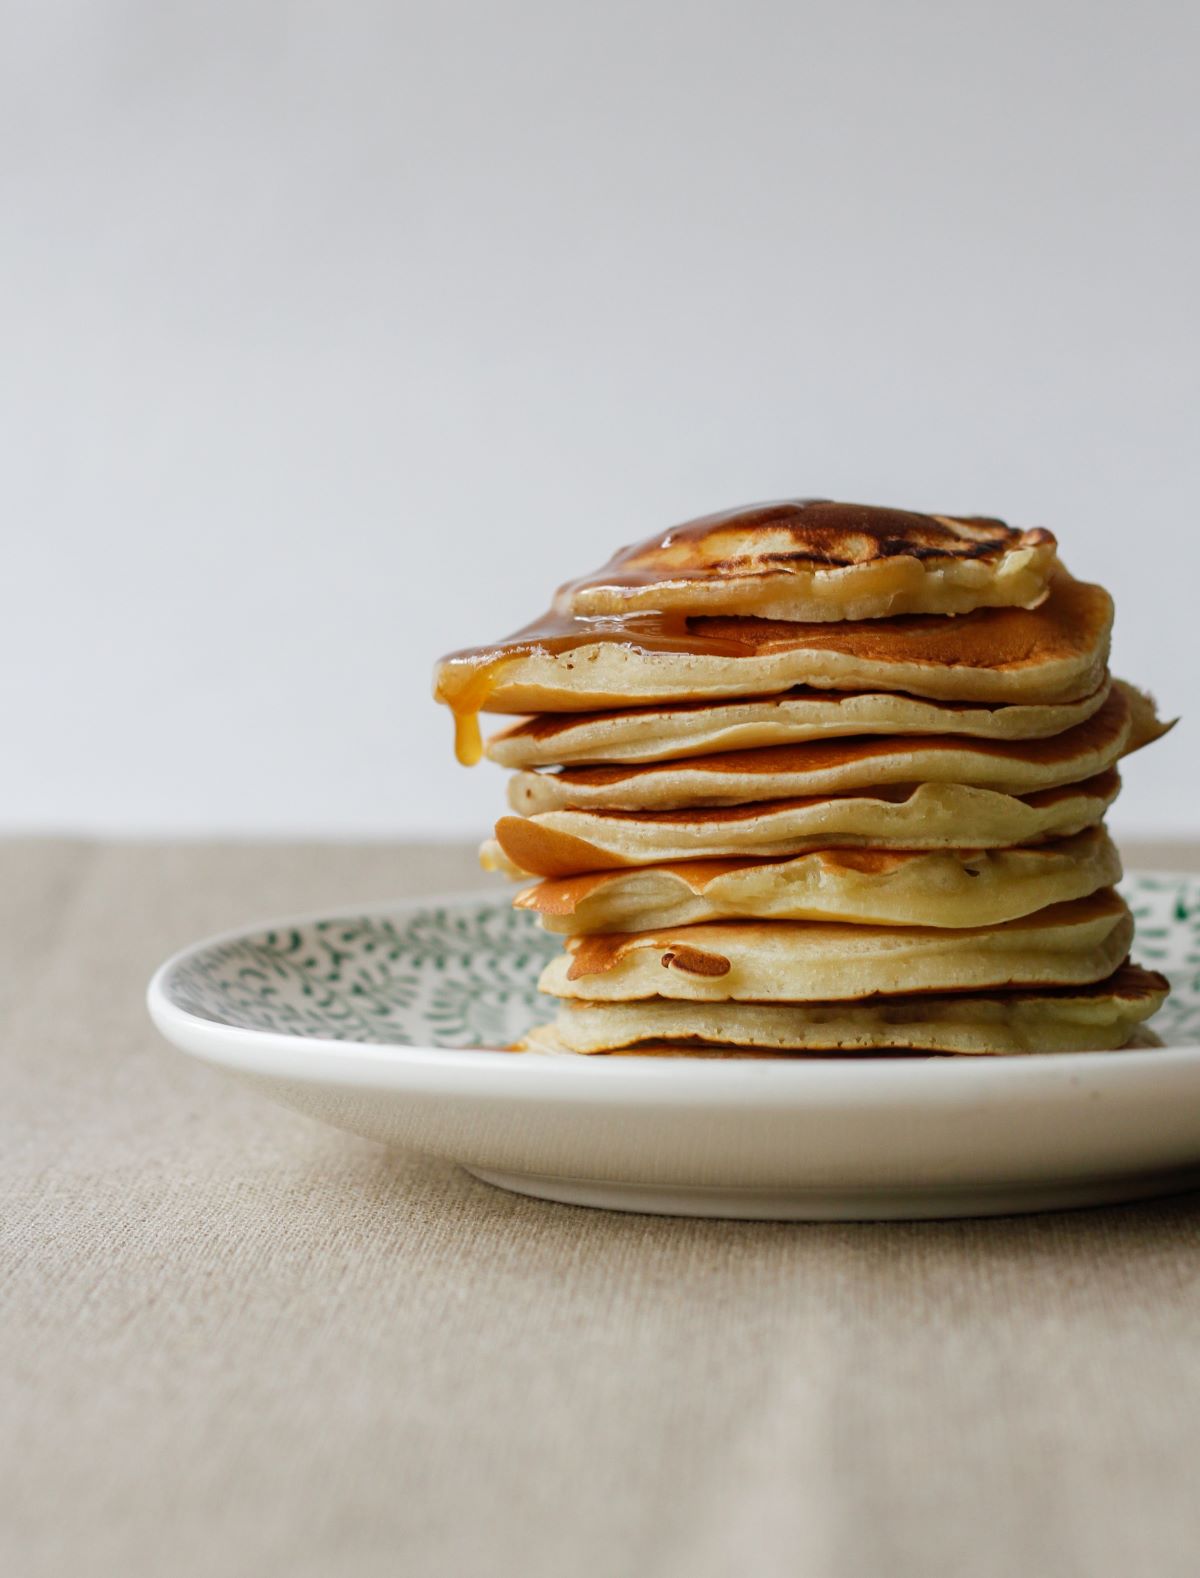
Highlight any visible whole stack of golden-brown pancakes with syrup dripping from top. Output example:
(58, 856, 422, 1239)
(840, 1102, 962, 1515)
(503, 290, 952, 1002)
(436, 500, 1167, 1056)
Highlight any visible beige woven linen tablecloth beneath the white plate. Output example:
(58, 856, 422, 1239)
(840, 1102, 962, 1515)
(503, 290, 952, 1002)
(0, 841, 1200, 1578)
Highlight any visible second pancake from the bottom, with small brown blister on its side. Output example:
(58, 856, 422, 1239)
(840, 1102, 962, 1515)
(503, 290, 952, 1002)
(538, 888, 1134, 1002)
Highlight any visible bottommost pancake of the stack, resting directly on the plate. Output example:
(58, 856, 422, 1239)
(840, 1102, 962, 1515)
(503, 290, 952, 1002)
(521, 964, 1168, 1057)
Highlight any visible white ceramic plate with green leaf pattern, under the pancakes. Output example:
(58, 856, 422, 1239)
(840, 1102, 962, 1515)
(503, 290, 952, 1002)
(148, 874, 1200, 1218)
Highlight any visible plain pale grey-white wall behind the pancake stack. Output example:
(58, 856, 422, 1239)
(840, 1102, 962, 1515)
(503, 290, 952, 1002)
(0, 0, 1200, 833)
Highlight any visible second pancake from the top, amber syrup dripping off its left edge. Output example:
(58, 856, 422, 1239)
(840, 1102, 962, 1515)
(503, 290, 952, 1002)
(434, 571, 1113, 762)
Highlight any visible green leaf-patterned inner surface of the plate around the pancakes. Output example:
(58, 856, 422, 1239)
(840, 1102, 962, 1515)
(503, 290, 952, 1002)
(166, 876, 1200, 1046)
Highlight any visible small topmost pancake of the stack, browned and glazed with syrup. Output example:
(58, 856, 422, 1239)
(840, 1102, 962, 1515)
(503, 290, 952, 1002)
(556, 499, 1055, 620)
